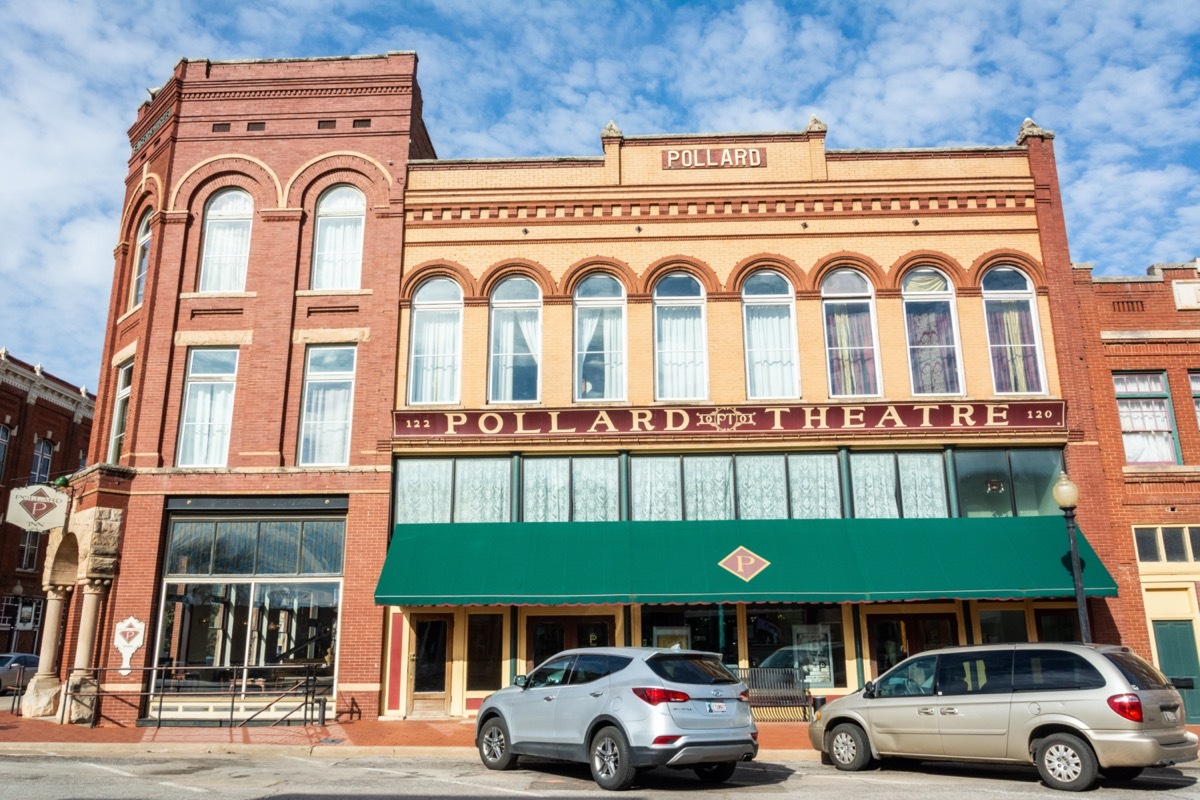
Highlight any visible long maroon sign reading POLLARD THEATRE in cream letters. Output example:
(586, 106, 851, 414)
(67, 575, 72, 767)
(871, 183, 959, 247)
(392, 401, 1066, 440)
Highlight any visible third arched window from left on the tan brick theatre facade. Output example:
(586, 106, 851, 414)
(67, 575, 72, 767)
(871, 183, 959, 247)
(575, 272, 625, 401)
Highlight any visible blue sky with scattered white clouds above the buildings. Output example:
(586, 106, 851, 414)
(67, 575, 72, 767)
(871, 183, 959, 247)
(0, 0, 1200, 387)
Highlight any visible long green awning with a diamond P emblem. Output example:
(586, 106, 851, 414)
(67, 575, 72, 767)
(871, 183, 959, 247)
(376, 517, 1117, 606)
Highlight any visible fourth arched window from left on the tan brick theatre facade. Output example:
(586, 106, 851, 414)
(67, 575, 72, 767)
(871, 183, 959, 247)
(654, 272, 708, 401)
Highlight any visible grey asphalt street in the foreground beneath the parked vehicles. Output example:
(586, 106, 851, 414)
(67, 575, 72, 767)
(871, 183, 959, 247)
(0, 748, 1200, 800)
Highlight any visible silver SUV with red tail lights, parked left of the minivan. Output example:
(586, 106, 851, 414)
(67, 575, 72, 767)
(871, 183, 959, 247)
(475, 648, 758, 789)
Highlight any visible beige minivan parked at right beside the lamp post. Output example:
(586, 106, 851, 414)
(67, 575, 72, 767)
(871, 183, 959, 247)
(809, 643, 1196, 792)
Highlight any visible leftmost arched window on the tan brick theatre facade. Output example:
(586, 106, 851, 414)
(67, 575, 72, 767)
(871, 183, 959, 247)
(408, 278, 462, 405)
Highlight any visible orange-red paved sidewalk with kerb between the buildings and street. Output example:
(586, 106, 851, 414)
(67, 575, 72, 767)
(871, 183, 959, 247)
(0, 711, 818, 760)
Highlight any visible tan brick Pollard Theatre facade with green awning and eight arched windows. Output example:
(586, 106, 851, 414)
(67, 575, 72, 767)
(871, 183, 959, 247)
(376, 118, 1123, 716)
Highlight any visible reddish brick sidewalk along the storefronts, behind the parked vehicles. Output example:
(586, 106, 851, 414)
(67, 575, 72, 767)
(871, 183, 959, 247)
(0, 711, 816, 758)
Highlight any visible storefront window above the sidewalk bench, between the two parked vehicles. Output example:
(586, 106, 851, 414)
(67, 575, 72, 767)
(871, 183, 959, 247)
(746, 604, 846, 688)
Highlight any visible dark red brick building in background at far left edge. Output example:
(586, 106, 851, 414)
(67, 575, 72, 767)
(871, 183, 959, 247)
(0, 348, 96, 654)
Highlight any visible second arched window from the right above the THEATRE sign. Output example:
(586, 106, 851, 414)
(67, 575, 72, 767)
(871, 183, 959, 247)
(901, 266, 962, 395)
